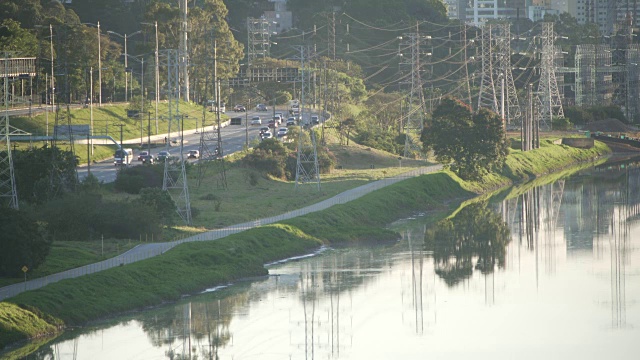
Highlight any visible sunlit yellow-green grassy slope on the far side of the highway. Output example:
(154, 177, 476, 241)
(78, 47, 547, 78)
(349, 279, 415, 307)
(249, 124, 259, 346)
(11, 102, 227, 164)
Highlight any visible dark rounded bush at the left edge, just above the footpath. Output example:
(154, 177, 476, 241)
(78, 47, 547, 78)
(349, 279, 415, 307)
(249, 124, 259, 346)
(0, 207, 51, 276)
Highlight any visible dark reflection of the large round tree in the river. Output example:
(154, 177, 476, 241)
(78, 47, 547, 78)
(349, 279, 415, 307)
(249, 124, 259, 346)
(425, 202, 511, 286)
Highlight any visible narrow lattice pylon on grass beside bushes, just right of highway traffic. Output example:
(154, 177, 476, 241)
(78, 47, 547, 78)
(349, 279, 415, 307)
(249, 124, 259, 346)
(296, 46, 320, 190)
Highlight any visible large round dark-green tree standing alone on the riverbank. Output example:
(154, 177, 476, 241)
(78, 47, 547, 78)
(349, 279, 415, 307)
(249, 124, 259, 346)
(421, 98, 508, 180)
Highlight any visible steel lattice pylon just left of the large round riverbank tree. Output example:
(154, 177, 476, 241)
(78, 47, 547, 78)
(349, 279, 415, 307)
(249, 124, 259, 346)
(401, 25, 430, 157)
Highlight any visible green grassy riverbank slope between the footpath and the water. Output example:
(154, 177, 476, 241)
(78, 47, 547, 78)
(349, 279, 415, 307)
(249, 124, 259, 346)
(0, 138, 607, 347)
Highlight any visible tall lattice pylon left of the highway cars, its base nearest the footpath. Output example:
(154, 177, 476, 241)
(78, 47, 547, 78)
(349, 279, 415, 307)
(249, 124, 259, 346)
(162, 49, 191, 225)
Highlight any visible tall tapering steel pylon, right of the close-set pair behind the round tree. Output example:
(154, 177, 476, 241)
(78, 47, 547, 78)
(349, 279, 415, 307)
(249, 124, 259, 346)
(538, 23, 564, 130)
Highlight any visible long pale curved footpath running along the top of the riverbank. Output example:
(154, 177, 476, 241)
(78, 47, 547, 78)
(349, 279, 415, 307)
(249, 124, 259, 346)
(0, 165, 442, 301)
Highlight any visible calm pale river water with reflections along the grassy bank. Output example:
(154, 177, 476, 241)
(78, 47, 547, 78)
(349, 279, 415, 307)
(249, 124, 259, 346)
(12, 160, 640, 360)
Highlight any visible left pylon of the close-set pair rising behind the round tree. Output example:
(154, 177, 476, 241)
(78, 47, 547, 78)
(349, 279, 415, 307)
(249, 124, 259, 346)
(478, 24, 498, 112)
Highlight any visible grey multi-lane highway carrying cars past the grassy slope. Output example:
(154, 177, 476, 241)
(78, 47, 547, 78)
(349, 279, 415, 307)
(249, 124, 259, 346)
(78, 109, 310, 183)
